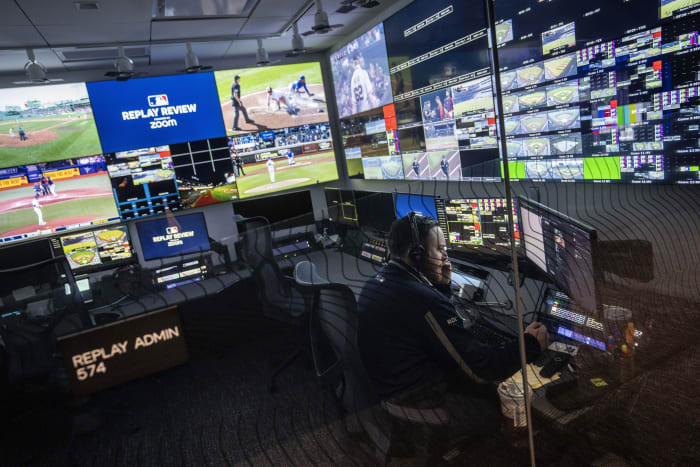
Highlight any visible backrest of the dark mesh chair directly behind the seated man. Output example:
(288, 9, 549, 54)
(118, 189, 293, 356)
(311, 284, 378, 412)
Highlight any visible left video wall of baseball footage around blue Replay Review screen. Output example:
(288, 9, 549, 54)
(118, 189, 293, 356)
(0, 63, 338, 247)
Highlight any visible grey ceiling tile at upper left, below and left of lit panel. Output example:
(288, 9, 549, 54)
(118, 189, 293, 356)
(39, 23, 149, 45)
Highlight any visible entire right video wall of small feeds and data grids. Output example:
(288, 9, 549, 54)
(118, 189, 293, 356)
(331, 0, 700, 184)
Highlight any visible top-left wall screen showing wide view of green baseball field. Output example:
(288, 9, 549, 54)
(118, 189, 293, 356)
(0, 83, 102, 167)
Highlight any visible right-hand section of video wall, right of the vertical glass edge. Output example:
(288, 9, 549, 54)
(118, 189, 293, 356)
(495, 0, 700, 184)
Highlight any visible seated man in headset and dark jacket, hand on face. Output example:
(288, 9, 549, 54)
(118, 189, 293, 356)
(358, 213, 548, 431)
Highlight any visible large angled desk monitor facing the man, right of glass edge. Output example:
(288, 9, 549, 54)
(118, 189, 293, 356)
(519, 198, 599, 313)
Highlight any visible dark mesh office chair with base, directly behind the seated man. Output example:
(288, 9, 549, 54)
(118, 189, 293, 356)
(307, 283, 449, 464)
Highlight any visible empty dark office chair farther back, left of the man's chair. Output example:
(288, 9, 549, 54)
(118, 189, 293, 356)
(239, 217, 309, 393)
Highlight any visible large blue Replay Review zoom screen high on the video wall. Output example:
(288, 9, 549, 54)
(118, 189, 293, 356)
(86, 73, 226, 153)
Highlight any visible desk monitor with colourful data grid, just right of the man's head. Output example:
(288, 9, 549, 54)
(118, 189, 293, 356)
(435, 198, 520, 255)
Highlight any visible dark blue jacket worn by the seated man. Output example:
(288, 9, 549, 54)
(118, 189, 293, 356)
(358, 261, 540, 399)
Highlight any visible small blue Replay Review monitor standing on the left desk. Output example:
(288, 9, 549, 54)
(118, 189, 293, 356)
(136, 212, 211, 261)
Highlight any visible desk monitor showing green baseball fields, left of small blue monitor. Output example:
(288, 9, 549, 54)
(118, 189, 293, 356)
(55, 225, 134, 272)
